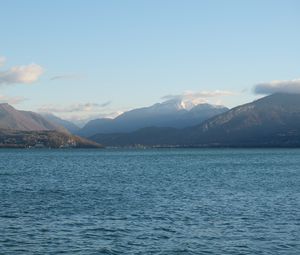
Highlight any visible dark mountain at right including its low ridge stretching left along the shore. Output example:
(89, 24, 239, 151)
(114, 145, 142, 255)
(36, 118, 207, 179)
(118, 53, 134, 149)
(92, 94, 300, 147)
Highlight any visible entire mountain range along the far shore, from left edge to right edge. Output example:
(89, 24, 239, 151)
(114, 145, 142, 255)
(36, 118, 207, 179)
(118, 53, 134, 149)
(0, 93, 300, 148)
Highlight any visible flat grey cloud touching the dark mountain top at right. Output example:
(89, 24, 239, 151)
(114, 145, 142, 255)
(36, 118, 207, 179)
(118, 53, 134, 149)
(253, 79, 300, 95)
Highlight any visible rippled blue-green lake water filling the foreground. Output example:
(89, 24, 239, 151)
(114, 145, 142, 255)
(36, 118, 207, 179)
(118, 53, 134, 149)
(0, 149, 300, 255)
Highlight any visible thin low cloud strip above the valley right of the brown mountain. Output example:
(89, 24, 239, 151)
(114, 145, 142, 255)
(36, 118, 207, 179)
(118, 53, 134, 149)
(38, 101, 111, 113)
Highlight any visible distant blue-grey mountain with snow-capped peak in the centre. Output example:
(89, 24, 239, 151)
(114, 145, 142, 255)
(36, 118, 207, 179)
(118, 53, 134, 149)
(78, 100, 228, 137)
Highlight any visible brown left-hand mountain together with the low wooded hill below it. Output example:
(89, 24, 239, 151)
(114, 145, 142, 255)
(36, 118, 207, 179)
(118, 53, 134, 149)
(0, 103, 102, 148)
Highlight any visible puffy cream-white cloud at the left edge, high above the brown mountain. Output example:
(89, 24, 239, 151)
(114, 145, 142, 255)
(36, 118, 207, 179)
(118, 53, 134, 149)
(0, 64, 44, 85)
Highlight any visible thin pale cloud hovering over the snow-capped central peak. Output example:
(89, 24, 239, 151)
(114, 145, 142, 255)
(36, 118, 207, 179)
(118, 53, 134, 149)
(162, 90, 235, 104)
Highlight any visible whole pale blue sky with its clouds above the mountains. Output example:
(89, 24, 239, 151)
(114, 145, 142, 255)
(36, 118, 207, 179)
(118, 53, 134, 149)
(0, 0, 300, 120)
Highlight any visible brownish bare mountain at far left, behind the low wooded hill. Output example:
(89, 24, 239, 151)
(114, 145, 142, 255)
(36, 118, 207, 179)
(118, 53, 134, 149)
(0, 103, 67, 132)
